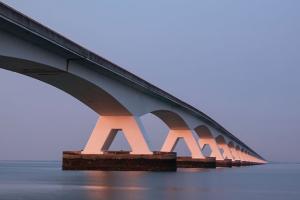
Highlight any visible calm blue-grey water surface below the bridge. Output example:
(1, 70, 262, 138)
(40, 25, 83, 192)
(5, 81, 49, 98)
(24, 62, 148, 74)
(0, 161, 300, 200)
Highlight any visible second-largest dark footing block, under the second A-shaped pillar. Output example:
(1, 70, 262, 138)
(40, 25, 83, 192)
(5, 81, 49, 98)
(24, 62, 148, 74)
(177, 157, 216, 168)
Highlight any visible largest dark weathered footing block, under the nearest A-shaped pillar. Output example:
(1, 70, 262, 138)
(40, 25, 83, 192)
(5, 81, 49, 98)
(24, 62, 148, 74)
(62, 151, 177, 171)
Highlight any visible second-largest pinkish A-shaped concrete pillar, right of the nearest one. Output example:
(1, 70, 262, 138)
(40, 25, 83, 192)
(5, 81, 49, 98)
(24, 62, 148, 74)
(161, 130, 205, 158)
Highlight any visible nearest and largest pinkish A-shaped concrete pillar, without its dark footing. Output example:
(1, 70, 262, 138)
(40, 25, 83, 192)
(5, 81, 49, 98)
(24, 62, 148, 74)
(82, 116, 152, 154)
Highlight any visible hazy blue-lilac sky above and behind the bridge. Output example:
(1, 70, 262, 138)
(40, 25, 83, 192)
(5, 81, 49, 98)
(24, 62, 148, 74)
(0, 0, 300, 162)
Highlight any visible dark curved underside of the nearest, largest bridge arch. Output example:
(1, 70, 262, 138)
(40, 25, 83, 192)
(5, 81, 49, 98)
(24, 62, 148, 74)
(0, 56, 130, 115)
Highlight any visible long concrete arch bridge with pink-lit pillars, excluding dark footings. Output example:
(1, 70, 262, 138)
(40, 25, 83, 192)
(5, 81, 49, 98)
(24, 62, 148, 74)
(0, 2, 266, 170)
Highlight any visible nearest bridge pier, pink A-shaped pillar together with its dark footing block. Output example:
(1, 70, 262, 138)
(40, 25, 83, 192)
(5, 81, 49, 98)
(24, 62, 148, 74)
(62, 116, 177, 171)
